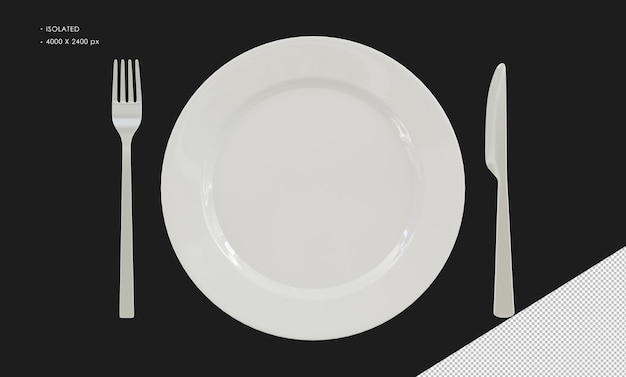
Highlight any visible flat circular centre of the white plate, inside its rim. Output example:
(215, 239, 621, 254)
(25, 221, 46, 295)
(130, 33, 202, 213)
(204, 83, 419, 288)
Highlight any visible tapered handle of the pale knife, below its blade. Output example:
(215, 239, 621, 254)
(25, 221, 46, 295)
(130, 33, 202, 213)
(493, 175, 515, 318)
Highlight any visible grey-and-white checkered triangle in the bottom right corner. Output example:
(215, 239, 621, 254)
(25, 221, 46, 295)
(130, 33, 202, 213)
(419, 248, 626, 377)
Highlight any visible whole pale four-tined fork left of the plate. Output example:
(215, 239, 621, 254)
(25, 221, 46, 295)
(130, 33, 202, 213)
(111, 59, 141, 318)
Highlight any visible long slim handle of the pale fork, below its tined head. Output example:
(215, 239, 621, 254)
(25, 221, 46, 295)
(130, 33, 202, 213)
(119, 140, 135, 318)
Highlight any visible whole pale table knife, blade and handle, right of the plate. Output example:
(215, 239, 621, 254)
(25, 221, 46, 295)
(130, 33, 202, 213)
(485, 63, 515, 318)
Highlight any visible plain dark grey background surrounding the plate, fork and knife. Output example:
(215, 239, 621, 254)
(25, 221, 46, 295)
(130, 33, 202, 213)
(11, 3, 626, 376)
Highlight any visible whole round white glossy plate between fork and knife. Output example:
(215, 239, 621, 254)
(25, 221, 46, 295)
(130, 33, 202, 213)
(161, 37, 465, 340)
